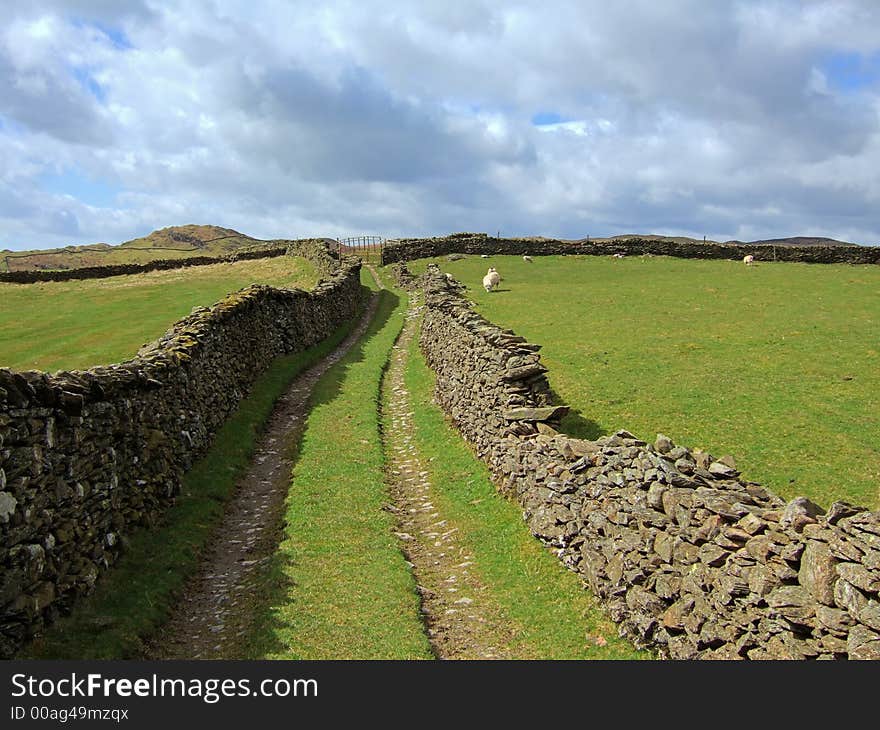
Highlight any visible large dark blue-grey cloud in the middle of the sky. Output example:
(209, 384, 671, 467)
(232, 62, 534, 182)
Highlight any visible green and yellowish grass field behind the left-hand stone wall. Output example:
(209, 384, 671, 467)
(0, 256, 318, 371)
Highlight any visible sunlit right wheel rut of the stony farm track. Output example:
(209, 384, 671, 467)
(382, 294, 531, 659)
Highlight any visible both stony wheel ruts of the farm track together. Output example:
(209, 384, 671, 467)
(144, 264, 531, 659)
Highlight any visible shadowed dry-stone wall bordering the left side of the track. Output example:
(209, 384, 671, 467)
(0, 245, 363, 658)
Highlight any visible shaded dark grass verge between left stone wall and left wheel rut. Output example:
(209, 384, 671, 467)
(19, 298, 368, 659)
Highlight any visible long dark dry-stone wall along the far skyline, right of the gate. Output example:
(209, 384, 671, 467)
(382, 233, 880, 264)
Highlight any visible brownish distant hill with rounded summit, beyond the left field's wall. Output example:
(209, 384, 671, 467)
(0, 225, 262, 271)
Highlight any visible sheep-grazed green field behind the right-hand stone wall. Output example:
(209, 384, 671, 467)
(411, 256, 880, 509)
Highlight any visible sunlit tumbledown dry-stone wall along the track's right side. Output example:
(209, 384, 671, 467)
(420, 267, 880, 659)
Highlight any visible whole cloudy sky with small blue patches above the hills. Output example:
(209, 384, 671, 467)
(0, 0, 880, 249)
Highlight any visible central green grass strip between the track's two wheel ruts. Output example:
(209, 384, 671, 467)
(249, 291, 432, 659)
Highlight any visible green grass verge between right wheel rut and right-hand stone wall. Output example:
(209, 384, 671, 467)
(406, 324, 650, 659)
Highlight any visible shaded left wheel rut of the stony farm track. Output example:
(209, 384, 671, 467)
(145, 295, 378, 659)
